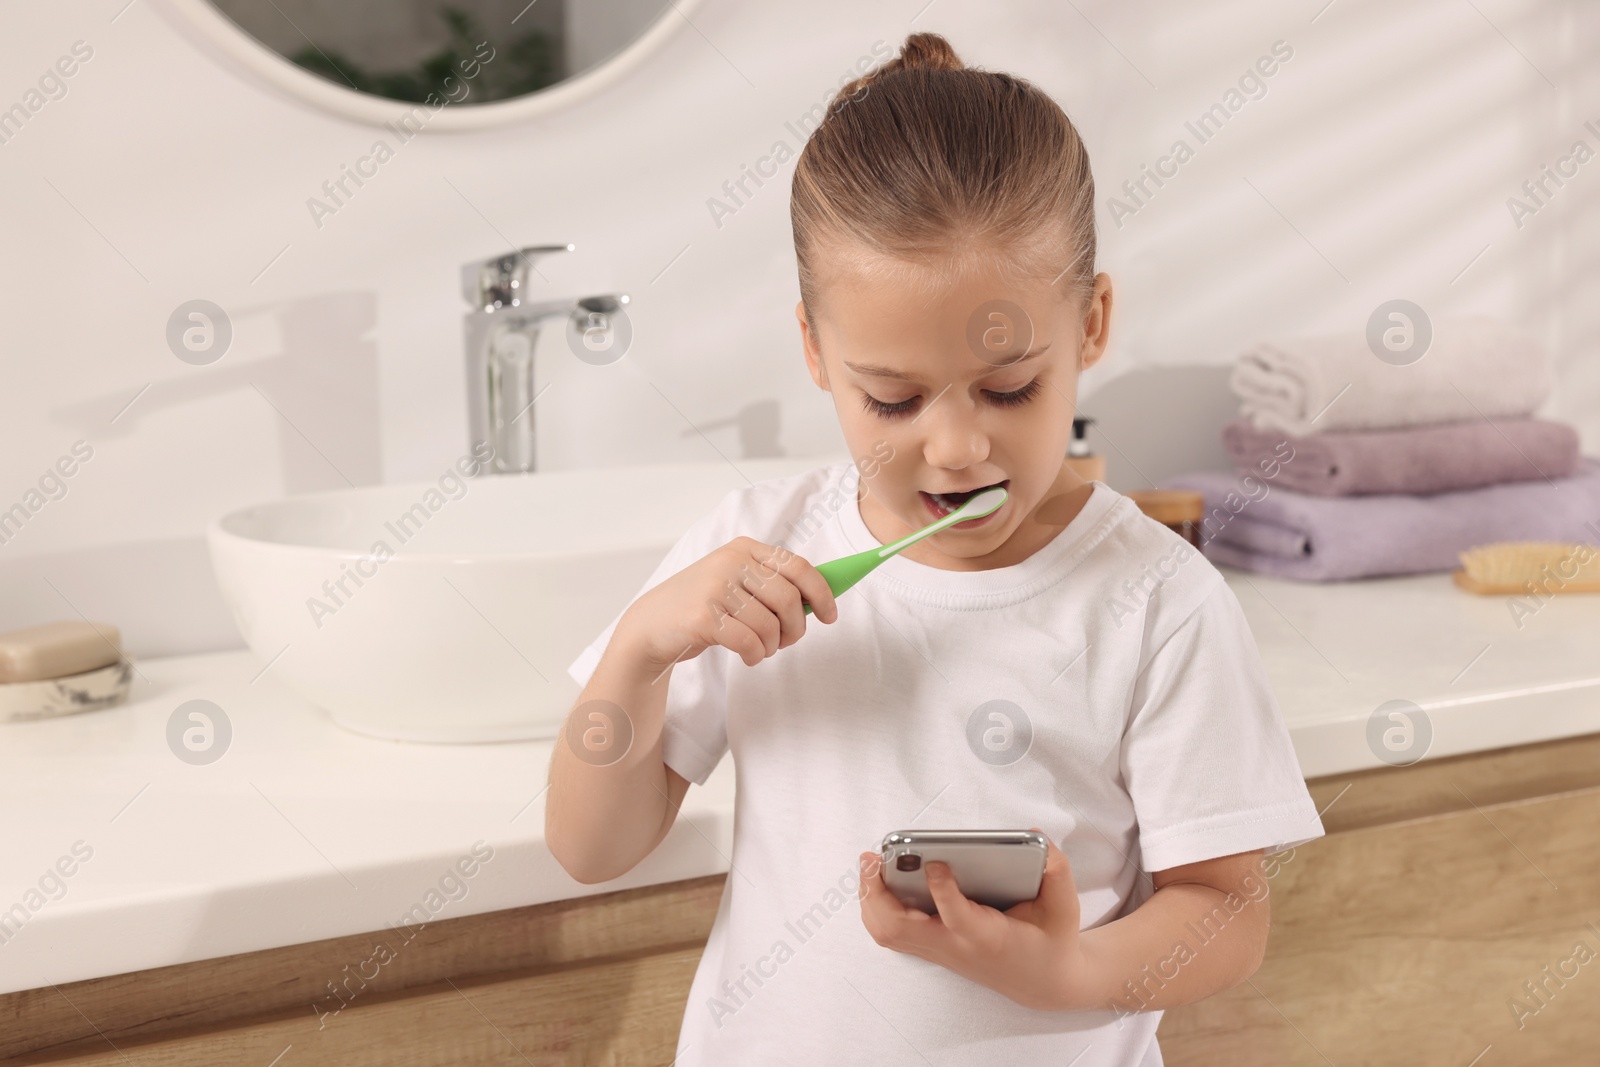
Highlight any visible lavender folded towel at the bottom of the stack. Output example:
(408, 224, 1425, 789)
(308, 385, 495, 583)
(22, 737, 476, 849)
(1168, 458, 1600, 582)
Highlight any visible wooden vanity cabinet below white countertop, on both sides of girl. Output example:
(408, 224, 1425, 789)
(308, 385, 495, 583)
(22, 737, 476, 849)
(0, 736, 1600, 1067)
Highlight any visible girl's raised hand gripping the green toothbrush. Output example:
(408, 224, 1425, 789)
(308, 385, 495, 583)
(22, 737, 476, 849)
(613, 537, 838, 673)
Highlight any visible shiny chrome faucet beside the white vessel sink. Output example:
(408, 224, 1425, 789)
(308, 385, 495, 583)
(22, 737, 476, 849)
(461, 245, 627, 474)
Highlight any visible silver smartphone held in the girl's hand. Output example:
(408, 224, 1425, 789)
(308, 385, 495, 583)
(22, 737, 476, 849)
(883, 830, 1050, 915)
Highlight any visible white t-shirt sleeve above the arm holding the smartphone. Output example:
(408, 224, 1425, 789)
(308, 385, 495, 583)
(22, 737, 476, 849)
(1122, 577, 1323, 872)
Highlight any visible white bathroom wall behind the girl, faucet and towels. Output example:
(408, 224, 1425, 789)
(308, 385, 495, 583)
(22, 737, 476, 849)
(0, 0, 1600, 654)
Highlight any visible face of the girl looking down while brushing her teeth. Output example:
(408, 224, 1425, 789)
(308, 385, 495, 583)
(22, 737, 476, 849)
(795, 249, 1110, 571)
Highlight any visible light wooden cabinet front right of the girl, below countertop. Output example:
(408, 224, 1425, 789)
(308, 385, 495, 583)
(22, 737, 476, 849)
(1160, 736, 1600, 1067)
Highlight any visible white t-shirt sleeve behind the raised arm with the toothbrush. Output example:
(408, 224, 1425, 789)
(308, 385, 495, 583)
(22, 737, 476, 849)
(566, 494, 733, 785)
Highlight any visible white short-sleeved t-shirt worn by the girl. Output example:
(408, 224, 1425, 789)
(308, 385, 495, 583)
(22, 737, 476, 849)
(570, 462, 1322, 1067)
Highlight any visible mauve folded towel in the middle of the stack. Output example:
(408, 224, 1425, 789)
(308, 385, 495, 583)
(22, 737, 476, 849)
(1222, 419, 1578, 496)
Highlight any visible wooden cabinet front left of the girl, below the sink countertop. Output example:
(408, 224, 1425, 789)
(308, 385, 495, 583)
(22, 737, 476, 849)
(0, 875, 723, 1067)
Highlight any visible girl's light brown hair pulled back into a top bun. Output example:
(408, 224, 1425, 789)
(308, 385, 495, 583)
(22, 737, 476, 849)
(789, 34, 1094, 333)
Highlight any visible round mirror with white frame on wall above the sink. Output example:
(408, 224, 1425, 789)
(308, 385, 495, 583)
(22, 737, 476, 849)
(157, 0, 698, 130)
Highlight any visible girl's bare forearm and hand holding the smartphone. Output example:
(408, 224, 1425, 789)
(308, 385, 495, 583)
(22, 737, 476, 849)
(861, 827, 1270, 1013)
